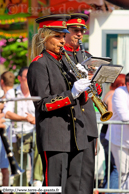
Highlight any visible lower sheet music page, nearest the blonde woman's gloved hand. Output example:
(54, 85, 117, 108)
(91, 65, 123, 83)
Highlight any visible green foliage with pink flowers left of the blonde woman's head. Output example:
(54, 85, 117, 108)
(1, 37, 28, 83)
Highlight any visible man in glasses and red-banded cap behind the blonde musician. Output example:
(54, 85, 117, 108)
(64, 13, 102, 194)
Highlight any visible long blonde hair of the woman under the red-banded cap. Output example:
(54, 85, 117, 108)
(31, 28, 56, 59)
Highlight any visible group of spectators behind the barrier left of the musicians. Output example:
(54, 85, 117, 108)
(0, 67, 43, 194)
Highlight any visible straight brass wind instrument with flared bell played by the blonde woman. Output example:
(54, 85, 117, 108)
(61, 47, 113, 121)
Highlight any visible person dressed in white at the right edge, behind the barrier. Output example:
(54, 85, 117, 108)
(106, 73, 129, 189)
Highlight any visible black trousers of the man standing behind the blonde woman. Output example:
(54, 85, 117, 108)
(78, 137, 96, 194)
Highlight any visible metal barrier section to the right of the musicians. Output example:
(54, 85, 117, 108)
(94, 120, 129, 193)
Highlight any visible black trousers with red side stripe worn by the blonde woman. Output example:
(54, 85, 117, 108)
(40, 151, 84, 194)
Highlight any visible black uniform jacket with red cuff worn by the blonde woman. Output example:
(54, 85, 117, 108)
(27, 51, 88, 153)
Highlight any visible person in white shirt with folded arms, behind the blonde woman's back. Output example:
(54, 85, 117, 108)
(3, 67, 42, 189)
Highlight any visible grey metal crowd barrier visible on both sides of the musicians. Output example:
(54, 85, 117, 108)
(1, 119, 129, 193)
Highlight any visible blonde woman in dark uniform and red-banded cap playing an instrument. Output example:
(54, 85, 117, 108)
(27, 14, 90, 194)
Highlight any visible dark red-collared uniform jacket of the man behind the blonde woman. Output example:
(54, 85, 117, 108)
(63, 45, 98, 138)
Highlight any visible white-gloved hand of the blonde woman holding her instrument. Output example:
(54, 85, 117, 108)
(71, 78, 91, 99)
